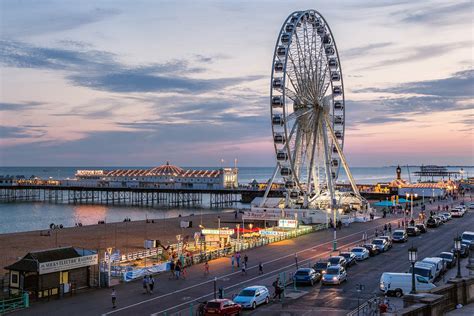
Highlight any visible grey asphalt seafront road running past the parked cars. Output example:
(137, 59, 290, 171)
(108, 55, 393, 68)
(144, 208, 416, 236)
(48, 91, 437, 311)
(18, 196, 474, 316)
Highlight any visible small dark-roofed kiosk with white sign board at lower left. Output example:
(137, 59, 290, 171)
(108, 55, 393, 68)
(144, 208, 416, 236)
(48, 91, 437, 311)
(5, 247, 98, 299)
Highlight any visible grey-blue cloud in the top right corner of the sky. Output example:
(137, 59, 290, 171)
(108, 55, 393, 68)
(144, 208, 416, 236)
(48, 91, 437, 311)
(394, 1, 473, 26)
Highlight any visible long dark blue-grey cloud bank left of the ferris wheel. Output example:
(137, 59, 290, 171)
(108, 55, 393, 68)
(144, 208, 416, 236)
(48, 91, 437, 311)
(0, 40, 263, 94)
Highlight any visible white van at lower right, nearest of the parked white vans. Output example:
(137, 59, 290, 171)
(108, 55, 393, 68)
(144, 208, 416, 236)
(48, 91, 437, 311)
(380, 272, 436, 297)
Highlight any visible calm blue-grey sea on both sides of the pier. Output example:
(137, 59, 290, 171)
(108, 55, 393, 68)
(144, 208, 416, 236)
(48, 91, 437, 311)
(0, 166, 474, 234)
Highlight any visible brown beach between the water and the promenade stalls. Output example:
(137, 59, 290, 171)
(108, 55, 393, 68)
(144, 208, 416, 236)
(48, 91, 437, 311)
(0, 212, 240, 274)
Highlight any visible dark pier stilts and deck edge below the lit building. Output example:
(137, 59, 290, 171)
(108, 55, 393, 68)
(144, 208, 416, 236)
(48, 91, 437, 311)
(0, 185, 283, 208)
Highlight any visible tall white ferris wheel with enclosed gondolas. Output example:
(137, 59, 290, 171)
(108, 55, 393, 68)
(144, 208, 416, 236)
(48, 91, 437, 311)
(270, 10, 360, 207)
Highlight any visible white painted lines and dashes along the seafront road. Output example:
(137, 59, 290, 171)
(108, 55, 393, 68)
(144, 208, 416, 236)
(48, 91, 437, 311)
(102, 219, 399, 316)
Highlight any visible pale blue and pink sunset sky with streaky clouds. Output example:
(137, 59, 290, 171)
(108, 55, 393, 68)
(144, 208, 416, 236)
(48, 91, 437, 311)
(0, 0, 474, 166)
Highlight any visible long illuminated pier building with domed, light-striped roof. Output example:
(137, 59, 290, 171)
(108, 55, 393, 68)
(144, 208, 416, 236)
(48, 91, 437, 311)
(69, 162, 238, 189)
